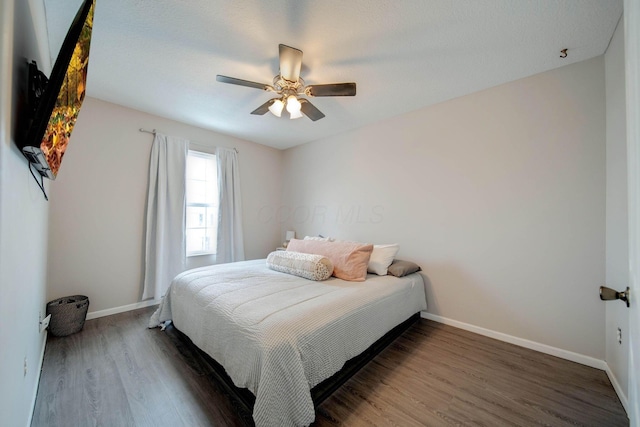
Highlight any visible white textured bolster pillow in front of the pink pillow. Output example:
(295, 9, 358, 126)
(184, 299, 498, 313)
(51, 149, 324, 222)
(267, 251, 333, 280)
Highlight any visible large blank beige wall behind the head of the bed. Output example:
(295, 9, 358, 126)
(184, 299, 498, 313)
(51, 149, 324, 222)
(277, 57, 605, 360)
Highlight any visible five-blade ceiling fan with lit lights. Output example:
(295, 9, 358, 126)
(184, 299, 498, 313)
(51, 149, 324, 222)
(216, 44, 356, 122)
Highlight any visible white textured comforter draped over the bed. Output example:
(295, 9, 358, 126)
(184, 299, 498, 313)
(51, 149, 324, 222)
(150, 260, 426, 426)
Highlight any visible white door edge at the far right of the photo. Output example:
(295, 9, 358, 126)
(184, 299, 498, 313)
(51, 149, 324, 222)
(624, 0, 640, 427)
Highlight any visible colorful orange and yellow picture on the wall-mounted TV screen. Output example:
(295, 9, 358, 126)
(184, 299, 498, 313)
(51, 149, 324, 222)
(40, 2, 95, 177)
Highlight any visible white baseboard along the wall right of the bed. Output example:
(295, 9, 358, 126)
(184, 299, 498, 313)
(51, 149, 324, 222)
(420, 311, 608, 372)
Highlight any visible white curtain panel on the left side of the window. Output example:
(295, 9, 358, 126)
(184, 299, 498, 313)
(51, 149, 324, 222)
(142, 133, 189, 300)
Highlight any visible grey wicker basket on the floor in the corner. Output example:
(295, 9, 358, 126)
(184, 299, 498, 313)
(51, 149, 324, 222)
(47, 295, 89, 337)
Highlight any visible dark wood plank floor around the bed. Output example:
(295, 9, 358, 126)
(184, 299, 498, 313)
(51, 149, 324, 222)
(32, 307, 629, 427)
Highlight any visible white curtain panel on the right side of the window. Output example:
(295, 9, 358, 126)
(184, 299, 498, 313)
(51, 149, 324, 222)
(216, 147, 244, 264)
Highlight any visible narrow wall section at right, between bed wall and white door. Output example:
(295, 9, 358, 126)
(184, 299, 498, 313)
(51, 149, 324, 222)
(605, 19, 629, 410)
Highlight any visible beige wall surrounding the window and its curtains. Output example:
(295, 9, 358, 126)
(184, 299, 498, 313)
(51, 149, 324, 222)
(47, 97, 282, 313)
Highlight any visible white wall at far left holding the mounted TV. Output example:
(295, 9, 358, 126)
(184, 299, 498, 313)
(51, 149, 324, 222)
(0, 0, 50, 427)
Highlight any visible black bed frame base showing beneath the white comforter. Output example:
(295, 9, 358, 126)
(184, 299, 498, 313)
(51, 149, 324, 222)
(166, 313, 420, 425)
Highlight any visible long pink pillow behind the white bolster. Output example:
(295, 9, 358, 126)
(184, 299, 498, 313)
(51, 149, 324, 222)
(287, 239, 373, 282)
